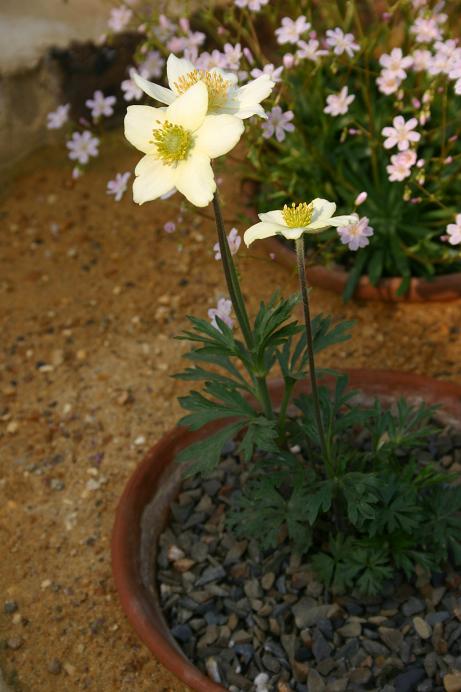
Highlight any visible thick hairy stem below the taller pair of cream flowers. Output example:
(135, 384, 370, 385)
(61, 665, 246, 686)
(213, 192, 274, 418)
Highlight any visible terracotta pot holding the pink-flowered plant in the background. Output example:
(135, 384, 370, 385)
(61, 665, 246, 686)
(262, 238, 461, 303)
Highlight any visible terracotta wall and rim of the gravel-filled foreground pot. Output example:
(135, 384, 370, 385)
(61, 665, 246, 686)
(112, 370, 461, 692)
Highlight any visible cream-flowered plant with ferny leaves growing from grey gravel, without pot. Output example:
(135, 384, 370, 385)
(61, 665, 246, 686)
(122, 54, 461, 593)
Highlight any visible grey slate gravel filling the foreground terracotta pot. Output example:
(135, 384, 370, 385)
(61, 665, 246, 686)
(157, 434, 461, 692)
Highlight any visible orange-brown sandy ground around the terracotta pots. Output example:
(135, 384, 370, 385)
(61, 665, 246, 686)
(0, 137, 461, 692)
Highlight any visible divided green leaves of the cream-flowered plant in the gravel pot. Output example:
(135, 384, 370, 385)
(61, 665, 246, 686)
(173, 293, 461, 594)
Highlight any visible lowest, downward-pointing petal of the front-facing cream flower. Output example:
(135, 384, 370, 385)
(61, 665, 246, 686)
(175, 149, 216, 207)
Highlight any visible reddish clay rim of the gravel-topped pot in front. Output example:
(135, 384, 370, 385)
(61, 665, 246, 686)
(111, 369, 461, 692)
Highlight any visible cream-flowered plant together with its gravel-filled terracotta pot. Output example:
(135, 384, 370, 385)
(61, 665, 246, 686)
(113, 52, 461, 692)
